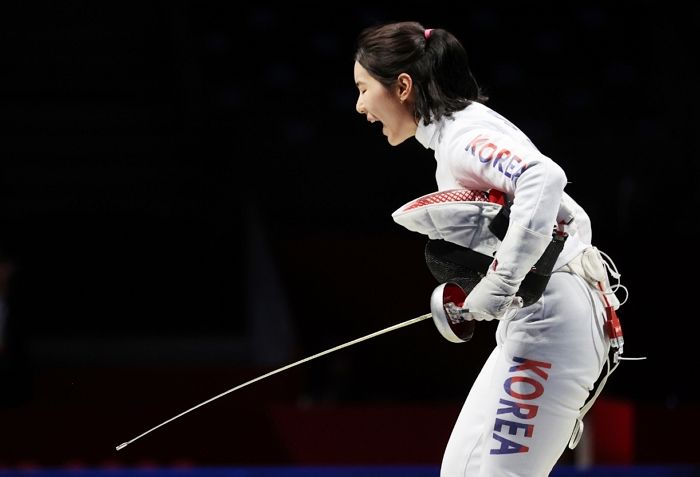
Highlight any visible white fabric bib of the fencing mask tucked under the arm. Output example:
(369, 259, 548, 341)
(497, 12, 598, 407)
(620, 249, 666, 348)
(391, 196, 501, 257)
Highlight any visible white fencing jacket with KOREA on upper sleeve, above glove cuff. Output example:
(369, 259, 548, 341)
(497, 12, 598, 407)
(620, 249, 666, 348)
(415, 103, 592, 269)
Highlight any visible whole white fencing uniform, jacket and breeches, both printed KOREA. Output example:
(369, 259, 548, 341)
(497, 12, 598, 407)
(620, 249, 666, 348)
(394, 103, 619, 477)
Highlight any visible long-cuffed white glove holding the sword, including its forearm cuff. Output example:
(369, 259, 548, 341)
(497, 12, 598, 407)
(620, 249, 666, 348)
(462, 221, 552, 320)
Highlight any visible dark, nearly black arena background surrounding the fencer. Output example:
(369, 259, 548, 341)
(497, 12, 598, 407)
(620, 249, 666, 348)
(0, 1, 700, 465)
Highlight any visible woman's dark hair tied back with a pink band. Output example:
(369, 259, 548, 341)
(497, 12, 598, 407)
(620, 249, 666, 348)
(355, 22, 488, 125)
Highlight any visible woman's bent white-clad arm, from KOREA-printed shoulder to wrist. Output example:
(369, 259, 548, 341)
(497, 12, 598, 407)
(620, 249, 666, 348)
(449, 131, 566, 318)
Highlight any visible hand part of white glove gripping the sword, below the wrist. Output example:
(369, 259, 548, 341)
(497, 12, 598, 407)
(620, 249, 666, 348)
(462, 274, 523, 321)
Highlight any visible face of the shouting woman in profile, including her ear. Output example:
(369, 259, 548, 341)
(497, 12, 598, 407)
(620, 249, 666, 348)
(355, 61, 418, 146)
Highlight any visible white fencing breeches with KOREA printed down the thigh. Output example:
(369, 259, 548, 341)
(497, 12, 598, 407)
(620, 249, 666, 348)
(440, 272, 609, 477)
